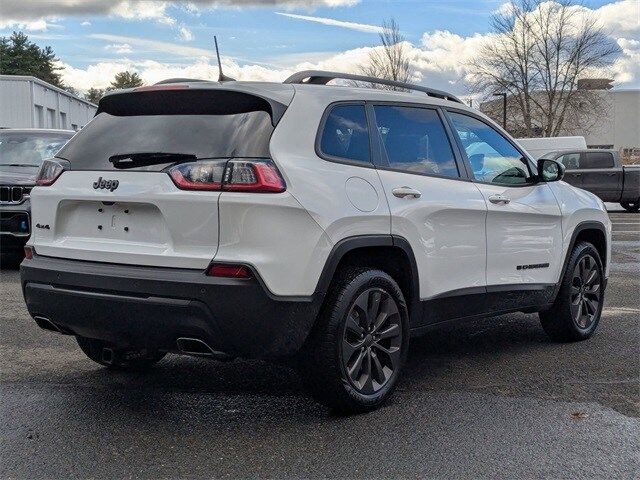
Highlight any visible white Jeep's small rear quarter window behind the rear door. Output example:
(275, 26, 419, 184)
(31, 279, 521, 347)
(320, 105, 370, 164)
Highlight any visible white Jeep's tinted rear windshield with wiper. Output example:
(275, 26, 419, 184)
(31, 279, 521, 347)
(58, 111, 273, 170)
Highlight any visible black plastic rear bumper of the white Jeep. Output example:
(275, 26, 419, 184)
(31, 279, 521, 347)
(20, 255, 320, 358)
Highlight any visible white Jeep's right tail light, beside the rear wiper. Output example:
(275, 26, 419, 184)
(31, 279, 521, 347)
(169, 159, 286, 193)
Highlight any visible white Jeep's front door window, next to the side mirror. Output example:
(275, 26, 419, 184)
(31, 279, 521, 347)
(449, 112, 533, 185)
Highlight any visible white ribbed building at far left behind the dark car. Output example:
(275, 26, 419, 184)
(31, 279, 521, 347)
(0, 75, 98, 130)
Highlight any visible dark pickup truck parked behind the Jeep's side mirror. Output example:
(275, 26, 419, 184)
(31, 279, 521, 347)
(542, 149, 640, 212)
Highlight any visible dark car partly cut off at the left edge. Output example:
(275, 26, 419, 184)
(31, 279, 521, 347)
(0, 128, 75, 263)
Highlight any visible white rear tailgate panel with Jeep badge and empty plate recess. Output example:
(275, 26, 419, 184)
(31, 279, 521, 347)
(30, 171, 220, 268)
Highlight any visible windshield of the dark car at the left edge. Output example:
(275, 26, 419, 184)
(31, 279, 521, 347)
(0, 132, 71, 167)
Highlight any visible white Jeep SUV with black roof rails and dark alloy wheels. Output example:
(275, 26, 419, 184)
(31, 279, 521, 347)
(21, 72, 611, 412)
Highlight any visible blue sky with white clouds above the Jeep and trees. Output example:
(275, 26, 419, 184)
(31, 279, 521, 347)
(0, 0, 640, 95)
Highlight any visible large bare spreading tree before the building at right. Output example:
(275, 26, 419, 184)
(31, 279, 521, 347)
(471, 0, 620, 136)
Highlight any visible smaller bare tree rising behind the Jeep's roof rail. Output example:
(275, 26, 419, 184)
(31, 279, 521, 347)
(360, 18, 413, 90)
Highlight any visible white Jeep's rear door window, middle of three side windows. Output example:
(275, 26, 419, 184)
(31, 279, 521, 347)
(374, 105, 459, 177)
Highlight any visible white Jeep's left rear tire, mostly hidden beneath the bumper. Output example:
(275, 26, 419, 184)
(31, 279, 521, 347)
(76, 337, 166, 371)
